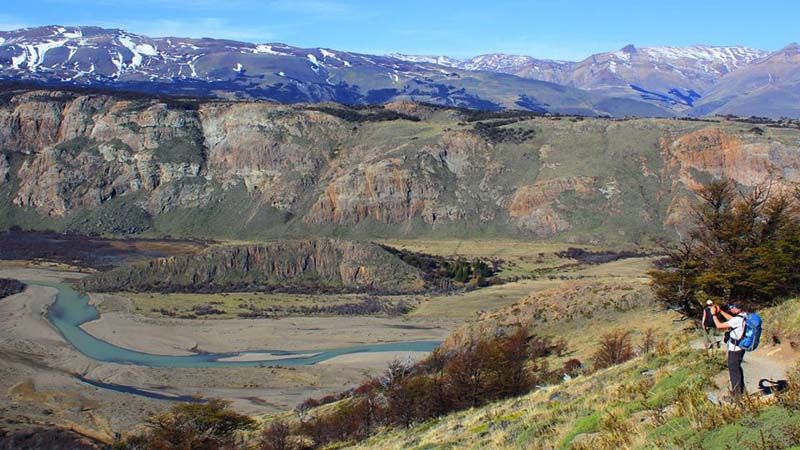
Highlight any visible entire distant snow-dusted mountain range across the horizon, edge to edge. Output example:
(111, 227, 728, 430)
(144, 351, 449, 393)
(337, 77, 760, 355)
(0, 26, 800, 117)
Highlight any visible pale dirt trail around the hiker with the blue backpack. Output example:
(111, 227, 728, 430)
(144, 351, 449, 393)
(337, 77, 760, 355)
(692, 337, 800, 398)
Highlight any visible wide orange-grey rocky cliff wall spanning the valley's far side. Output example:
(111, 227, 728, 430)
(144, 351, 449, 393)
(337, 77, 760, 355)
(0, 91, 800, 241)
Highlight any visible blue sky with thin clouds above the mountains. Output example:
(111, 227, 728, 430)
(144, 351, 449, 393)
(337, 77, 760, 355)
(0, 0, 800, 60)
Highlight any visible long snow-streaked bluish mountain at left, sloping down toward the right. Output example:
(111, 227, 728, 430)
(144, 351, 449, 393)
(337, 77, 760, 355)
(0, 26, 606, 114)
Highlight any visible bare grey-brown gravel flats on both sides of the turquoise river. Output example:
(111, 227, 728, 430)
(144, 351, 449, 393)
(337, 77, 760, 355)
(0, 262, 454, 433)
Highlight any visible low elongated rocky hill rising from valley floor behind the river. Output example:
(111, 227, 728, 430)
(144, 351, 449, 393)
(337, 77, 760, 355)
(80, 239, 426, 293)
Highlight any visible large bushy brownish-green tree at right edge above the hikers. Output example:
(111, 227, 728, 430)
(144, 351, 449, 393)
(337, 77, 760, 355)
(650, 180, 800, 317)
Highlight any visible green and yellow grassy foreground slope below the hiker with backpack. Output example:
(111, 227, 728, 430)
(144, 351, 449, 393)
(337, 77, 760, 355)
(353, 340, 800, 450)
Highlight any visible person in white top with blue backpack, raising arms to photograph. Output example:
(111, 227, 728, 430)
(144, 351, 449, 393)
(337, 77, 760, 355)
(711, 302, 761, 397)
